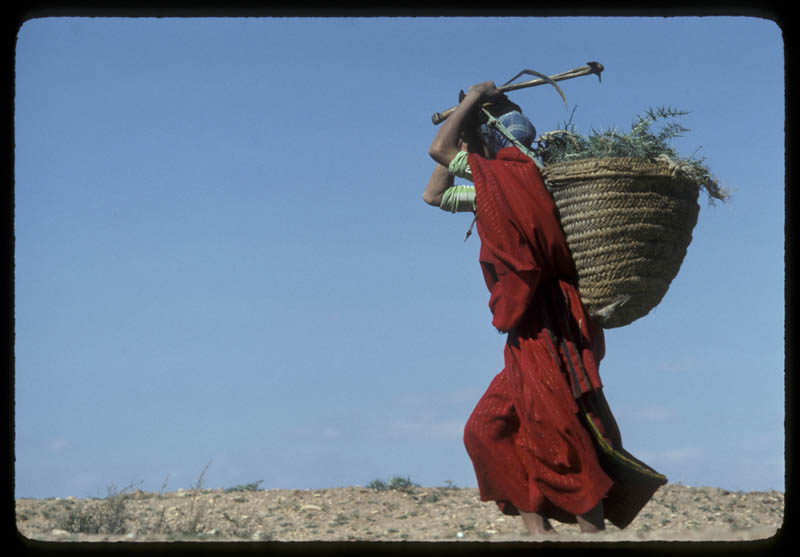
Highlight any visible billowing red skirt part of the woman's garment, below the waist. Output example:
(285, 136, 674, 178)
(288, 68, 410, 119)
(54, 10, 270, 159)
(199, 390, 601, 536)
(464, 369, 612, 522)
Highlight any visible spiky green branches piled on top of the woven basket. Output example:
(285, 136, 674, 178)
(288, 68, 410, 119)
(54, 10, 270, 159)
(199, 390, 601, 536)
(534, 107, 730, 203)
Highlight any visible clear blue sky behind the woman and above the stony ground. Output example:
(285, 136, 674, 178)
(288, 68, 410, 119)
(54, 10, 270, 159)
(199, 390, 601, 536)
(14, 17, 784, 497)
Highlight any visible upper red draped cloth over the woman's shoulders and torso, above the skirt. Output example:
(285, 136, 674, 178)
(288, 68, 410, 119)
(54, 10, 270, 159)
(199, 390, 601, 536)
(469, 147, 605, 397)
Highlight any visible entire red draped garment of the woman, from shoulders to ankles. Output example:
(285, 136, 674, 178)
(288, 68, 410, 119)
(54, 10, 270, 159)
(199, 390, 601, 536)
(464, 147, 636, 522)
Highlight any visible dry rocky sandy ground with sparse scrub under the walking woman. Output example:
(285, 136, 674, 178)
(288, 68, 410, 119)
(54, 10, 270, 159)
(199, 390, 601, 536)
(16, 484, 784, 542)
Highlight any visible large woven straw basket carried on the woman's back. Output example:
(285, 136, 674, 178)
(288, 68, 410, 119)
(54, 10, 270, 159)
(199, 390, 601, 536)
(542, 158, 700, 329)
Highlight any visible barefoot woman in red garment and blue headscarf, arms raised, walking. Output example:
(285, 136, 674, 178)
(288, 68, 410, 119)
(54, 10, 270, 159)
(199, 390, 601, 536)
(423, 81, 666, 534)
